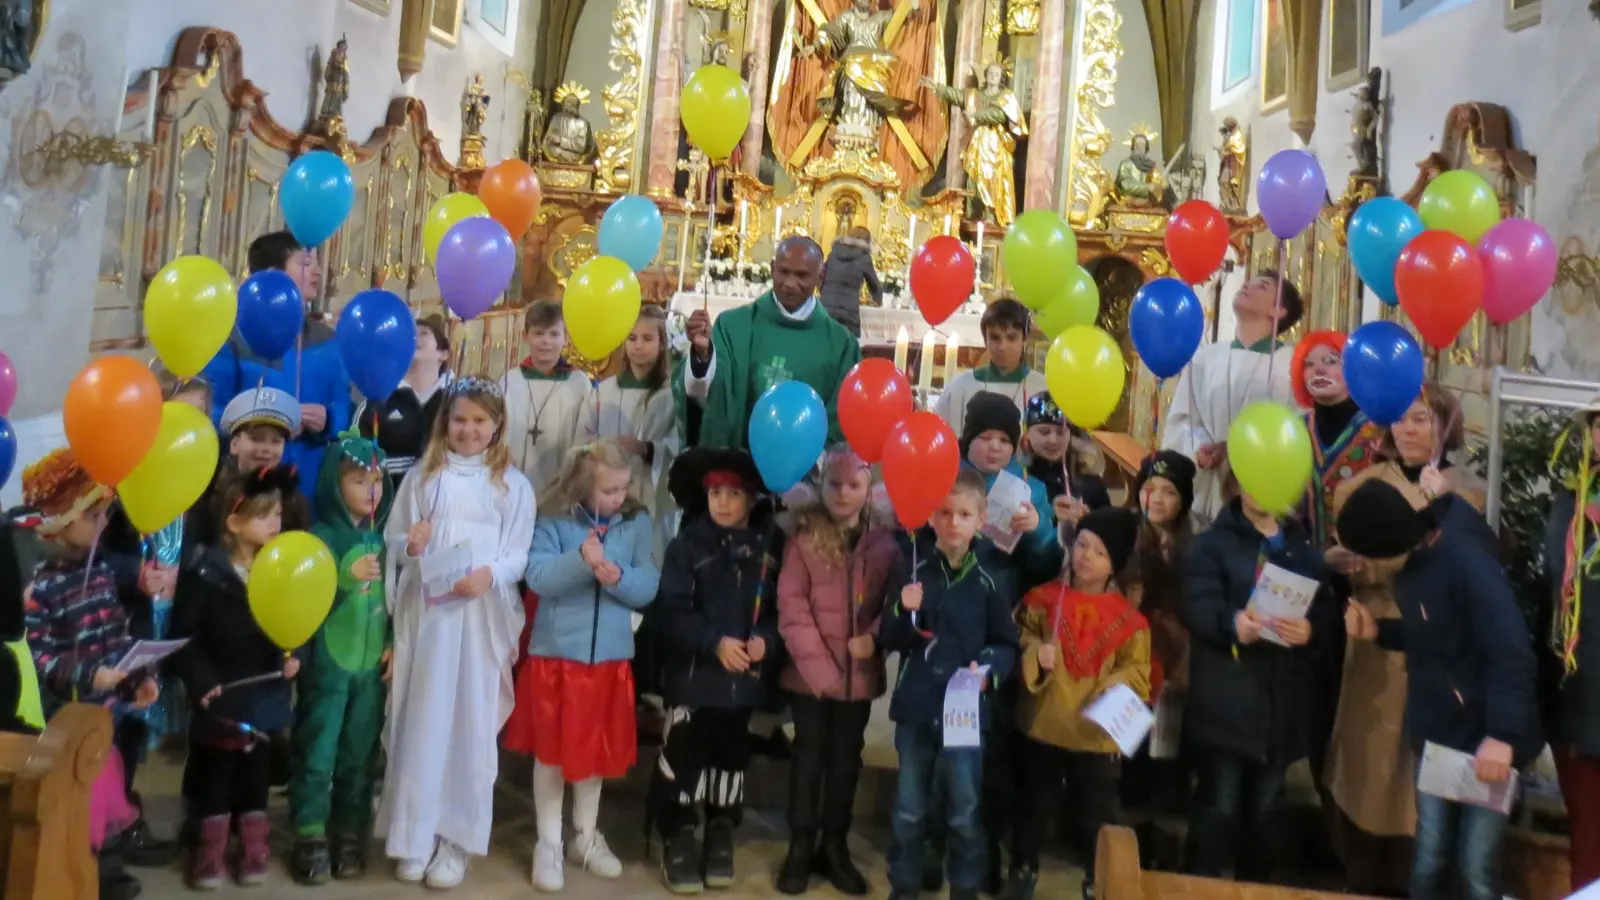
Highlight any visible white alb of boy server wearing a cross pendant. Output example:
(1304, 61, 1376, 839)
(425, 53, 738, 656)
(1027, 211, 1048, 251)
(501, 367, 594, 493)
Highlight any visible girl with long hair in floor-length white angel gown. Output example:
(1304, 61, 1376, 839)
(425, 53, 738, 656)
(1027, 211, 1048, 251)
(378, 378, 534, 889)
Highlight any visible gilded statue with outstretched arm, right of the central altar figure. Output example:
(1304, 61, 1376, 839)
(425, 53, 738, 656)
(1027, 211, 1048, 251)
(922, 62, 1027, 227)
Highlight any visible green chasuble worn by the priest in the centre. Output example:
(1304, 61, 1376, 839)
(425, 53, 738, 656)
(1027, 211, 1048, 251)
(680, 291, 861, 450)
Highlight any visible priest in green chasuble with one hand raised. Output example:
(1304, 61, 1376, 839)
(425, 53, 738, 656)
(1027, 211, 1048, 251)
(675, 235, 861, 450)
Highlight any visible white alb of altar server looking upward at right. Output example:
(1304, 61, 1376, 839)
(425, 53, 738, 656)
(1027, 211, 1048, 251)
(1162, 343, 1299, 527)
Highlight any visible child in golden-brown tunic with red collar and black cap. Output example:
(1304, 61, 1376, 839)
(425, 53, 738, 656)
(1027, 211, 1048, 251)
(1006, 506, 1152, 900)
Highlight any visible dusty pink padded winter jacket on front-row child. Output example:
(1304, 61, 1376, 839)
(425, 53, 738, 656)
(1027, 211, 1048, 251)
(778, 528, 899, 700)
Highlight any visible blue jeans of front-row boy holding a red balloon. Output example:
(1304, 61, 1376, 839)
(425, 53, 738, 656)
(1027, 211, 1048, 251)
(890, 725, 987, 895)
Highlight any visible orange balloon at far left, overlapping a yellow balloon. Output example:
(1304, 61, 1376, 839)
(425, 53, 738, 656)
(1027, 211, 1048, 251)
(61, 356, 162, 487)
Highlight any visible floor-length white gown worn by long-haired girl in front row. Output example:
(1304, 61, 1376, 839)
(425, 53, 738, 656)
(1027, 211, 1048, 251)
(376, 453, 534, 860)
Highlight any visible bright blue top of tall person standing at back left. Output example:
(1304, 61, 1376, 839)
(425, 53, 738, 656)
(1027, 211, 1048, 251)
(202, 322, 350, 496)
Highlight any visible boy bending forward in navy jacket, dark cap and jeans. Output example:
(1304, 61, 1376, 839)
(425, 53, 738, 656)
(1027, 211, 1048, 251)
(1338, 479, 1544, 900)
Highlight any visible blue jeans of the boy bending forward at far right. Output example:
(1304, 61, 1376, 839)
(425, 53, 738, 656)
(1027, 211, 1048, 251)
(1411, 791, 1507, 900)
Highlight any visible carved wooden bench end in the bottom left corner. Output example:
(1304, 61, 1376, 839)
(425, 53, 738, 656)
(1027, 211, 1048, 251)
(0, 703, 110, 900)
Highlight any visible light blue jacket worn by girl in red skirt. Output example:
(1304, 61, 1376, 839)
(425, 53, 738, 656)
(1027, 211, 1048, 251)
(526, 514, 661, 663)
